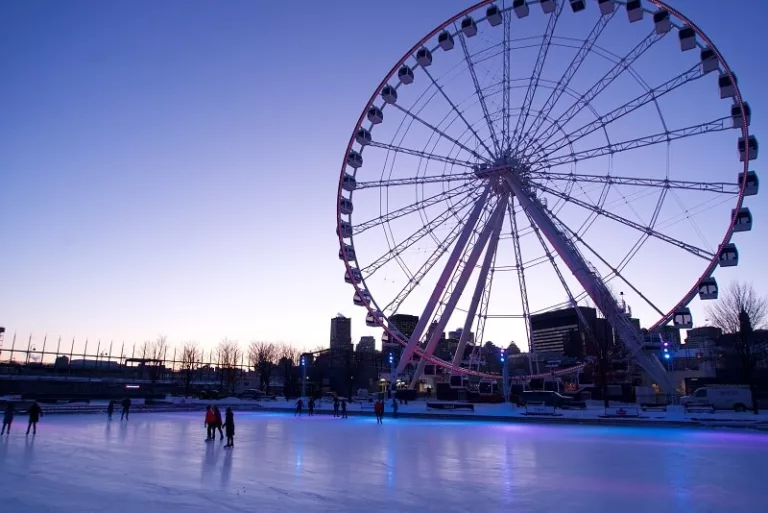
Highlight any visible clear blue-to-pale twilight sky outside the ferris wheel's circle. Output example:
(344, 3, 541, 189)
(0, 0, 768, 356)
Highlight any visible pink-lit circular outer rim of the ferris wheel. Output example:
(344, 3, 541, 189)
(336, 0, 750, 379)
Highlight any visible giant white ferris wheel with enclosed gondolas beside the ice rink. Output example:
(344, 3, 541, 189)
(336, 0, 758, 389)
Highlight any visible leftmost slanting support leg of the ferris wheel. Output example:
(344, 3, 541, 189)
(397, 184, 491, 374)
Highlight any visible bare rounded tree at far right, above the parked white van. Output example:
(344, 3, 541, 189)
(707, 281, 768, 333)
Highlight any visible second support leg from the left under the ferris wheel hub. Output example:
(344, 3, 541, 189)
(411, 196, 507, 388)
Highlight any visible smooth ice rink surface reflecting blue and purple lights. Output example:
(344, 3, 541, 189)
(0, 413, 768, 513)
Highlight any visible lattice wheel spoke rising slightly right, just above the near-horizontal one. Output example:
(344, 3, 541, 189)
(534, 117, 732, 171)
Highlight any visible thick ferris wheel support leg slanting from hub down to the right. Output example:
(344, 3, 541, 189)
(504, 171, 674, 393)
